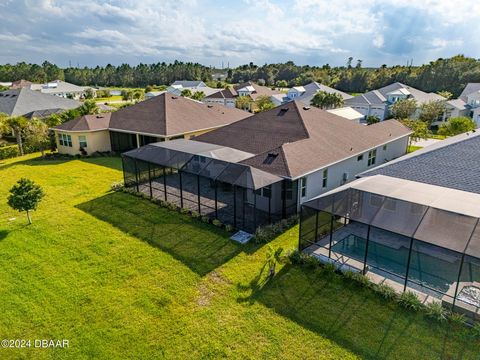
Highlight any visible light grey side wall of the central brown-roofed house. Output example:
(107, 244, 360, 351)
(299, 136, 408, 207)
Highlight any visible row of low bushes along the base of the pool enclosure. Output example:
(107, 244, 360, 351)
(288, 249, 480, 339)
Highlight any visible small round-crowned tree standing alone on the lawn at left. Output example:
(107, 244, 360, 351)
(8, 178, 45, 224)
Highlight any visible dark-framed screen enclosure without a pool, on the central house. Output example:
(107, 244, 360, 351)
(122, 145, 298, 233)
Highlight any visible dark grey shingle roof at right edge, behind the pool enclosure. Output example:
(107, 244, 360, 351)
(359, 132, 480, 194)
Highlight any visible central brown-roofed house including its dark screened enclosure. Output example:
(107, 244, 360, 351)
(123, 101, 411, 232)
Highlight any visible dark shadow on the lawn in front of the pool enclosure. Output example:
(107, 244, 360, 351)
(249, 265, 479, 359)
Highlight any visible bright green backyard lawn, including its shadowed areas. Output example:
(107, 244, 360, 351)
(0, 155, 479, 359)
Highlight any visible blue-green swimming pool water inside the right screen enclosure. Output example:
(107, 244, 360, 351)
(332, 234, 460, 293)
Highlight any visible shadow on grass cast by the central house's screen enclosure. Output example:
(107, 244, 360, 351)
(76, 193, 251, 276)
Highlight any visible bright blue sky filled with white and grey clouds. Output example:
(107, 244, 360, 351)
(0, 0, 480, 66)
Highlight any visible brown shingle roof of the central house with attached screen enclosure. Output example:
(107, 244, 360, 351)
(196, 101, 410, 178)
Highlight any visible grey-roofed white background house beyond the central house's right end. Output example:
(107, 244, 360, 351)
(345, 82, 446, 120)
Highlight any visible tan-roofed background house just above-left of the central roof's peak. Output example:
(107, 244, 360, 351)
(203, 81, 285, 107)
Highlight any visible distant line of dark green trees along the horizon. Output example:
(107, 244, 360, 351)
(0, 55, 480, 97)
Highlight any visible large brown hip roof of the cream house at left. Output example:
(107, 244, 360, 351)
(110, 93, 252, 136)
